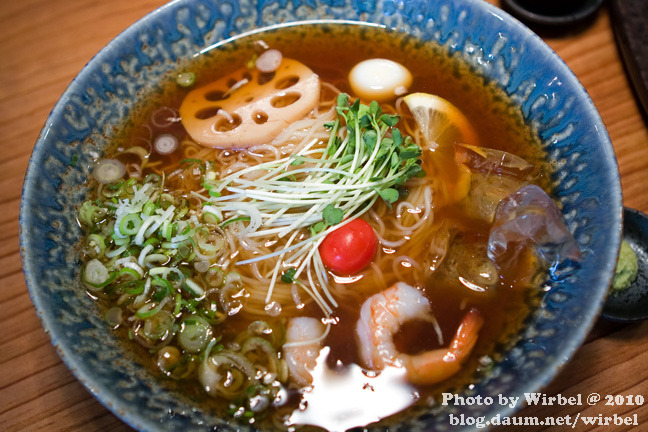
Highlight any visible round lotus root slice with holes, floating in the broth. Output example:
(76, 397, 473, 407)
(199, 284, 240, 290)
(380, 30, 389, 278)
(180, 58, 320, 149)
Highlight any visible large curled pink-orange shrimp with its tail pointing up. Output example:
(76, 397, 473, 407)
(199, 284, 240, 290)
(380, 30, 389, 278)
(356, 282, 484, 384)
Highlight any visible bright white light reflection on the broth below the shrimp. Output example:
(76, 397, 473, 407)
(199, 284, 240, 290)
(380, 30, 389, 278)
(287, 347, 418, 432)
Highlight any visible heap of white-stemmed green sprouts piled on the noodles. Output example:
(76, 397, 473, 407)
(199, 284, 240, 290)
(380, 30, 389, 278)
(203, 93, 425, 314)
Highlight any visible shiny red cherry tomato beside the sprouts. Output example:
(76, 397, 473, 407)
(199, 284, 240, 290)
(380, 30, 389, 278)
(319, 219, 378, 275)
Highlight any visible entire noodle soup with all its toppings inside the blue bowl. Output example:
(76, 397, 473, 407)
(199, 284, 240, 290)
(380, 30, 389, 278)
(79, 24, 578, 430)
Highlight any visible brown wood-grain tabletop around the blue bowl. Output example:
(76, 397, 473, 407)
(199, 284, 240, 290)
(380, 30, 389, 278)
(0, 0, 648, 432)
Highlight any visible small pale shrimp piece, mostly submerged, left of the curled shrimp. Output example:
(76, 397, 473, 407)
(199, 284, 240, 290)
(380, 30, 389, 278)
(284, 317, 326, 386)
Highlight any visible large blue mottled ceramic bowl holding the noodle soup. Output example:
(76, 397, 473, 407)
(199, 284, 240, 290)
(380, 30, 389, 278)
(20, 0, 622, 431)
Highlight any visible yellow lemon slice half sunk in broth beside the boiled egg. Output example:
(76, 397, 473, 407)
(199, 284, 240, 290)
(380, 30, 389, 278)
(403, 93, 479, 205)
